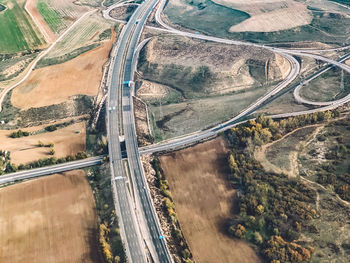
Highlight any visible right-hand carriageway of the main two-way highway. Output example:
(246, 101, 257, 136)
(115, 0, 172, 262)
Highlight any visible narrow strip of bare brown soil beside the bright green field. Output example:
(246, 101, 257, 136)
(25, 0, 57, 43)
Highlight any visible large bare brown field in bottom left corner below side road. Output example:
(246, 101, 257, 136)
(0, 170, 102, 263)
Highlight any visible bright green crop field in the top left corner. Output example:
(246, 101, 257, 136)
(0, 0, 45, 54)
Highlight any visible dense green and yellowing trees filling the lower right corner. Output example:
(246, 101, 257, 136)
(226, 111, 350, 262)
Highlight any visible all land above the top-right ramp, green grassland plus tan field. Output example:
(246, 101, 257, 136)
(164, 0, 350, 45)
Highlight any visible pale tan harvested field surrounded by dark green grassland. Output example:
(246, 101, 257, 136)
(214, 0, 312, 32)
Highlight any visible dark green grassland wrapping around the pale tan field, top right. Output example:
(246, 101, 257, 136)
(164, 0, 350, 45)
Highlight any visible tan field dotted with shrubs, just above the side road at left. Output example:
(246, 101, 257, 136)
(0, 122, 86, 165)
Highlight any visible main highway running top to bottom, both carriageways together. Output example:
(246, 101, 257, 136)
(104, 0, 172, 262)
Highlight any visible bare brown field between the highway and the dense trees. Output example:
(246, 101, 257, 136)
(160, 138, 260, 263)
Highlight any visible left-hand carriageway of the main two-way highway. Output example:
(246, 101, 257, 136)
(104, 1, 147, 263)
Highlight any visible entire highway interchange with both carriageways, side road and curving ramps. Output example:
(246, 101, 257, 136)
(0, 0, 350, 262)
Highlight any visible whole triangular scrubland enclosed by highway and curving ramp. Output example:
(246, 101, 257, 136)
(137, 37, 290, 141)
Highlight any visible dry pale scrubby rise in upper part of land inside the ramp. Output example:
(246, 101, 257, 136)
(139, 36, 290, 94)
